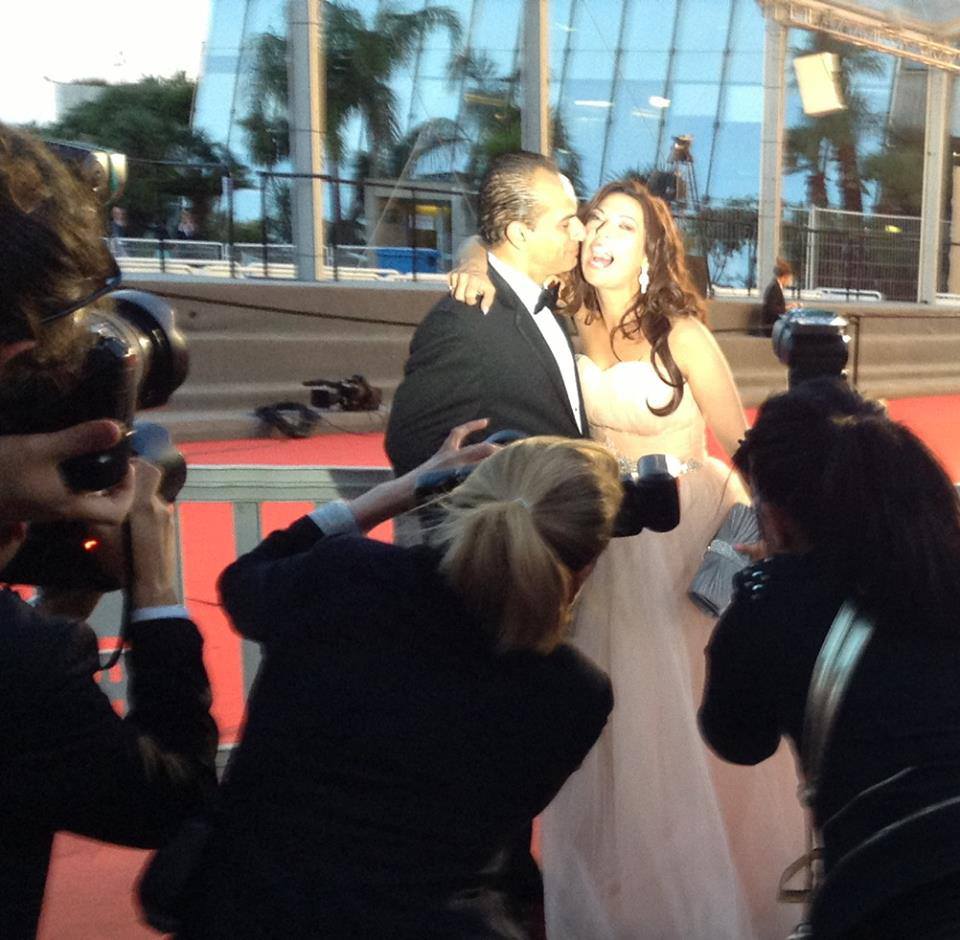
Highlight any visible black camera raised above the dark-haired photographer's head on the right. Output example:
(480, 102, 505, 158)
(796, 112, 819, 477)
(771, 307, 850, 388)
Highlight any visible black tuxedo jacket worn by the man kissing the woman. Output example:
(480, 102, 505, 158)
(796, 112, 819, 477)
(386, 268, 587, 474)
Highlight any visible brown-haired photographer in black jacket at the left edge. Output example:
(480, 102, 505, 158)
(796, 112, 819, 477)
(0, 125, 217, 938)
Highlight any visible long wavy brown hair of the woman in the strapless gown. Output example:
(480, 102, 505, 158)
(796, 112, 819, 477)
(571, 179, 706, 416)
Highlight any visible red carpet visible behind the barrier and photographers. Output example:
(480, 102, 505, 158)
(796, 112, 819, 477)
(40, 395, 960, 940)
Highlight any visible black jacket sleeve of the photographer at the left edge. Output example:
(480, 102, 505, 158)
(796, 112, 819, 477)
(0, 593, 217, 854)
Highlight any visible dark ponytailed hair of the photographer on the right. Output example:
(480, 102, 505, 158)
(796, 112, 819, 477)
(733, 379, 960, 636)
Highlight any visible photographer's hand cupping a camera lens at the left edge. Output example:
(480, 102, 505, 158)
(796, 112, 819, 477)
(0, 419, 133, 523)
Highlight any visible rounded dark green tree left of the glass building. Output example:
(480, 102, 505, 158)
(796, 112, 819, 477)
(40, 72, 242, 235)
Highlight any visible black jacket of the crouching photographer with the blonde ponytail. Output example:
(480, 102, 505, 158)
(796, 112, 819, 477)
(180, 518, 613, 940)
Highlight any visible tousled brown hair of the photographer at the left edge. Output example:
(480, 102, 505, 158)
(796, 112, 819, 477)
(0, 124, 114, 364)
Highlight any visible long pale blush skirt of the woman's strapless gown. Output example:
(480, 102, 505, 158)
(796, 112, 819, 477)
(542, 461, 803, 940)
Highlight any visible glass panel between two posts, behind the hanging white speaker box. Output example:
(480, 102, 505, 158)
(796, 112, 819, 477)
(783, 32, 926, 301)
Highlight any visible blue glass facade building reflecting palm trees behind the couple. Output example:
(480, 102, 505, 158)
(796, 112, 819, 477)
(194, 0, 960, 299)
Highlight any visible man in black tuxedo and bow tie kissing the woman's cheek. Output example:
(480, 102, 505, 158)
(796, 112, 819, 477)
(386, 151, 587, 474)
